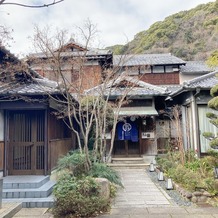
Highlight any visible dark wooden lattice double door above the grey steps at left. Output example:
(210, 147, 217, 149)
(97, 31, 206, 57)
(8, 110, 45, 175)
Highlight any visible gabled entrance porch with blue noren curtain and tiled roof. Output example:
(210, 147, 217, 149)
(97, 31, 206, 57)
(87, 74, 169, 157)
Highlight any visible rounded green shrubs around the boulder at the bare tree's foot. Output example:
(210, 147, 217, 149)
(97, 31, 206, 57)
(53, 151, 122, 217)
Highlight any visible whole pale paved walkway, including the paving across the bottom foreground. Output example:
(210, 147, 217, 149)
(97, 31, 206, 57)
(2, 169, 218, 218)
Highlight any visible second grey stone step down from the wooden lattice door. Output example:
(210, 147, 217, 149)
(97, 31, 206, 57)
(2, 180, 55, 198)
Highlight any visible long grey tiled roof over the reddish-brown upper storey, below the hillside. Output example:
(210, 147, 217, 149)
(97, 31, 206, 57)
(113, 53, 186, 66)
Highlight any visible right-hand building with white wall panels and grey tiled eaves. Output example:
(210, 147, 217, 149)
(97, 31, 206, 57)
(167, 71, 218, 157)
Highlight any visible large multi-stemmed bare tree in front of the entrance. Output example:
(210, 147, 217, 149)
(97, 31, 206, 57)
(28, 21, 138, 168)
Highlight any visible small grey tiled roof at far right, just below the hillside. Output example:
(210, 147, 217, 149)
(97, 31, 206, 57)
(180, 61, 213, 74)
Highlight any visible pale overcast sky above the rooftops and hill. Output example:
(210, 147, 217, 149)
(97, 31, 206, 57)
(0, 0, 215, 54)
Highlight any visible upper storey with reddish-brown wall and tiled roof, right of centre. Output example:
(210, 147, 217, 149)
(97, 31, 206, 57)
(113, 53, 186, 85)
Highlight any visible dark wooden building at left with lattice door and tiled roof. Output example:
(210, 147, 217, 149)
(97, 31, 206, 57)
(0, 47, 74, 176)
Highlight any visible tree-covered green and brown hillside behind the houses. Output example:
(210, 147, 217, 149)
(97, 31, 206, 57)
(108, 0, 218, 60)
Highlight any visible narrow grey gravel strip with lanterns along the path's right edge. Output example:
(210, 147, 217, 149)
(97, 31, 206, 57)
(147, 170, 193, 206)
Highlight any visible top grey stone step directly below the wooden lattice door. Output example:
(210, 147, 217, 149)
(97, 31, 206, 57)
(3, 175, 50, 189)
